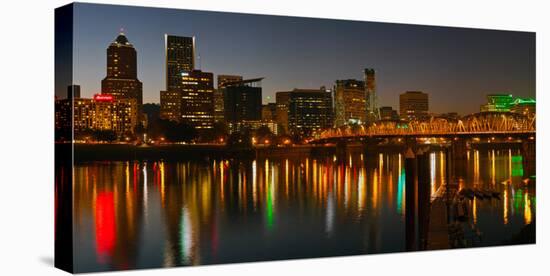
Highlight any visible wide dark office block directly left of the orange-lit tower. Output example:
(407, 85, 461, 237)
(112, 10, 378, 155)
(288, 89, 333, 138)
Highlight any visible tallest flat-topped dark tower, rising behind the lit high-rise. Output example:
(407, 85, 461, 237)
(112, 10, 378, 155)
(164, 34, 195, 91)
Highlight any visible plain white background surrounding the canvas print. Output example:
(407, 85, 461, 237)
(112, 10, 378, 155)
(0, 0, 550, 276)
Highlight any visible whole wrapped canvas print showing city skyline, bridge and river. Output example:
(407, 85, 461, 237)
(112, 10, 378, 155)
(54, 3, 540, 273)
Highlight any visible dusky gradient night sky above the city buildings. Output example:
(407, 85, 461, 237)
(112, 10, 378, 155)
(68, 4, 535, 114)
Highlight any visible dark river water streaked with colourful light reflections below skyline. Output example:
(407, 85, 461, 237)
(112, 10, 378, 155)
(74, 150, 536, 271)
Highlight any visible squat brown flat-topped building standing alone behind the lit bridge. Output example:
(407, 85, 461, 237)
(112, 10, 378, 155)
(399, 91, 429, 120)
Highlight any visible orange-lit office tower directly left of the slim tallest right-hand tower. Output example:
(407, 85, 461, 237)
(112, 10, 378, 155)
(334, 79, 367, 127)
